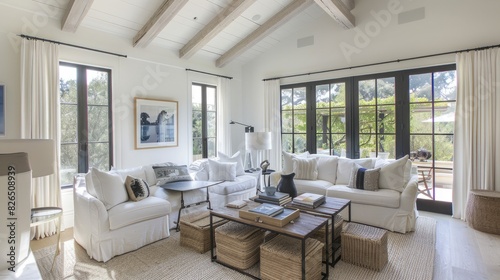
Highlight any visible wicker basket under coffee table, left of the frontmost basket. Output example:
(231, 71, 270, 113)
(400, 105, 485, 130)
(215, 222, 265, 269)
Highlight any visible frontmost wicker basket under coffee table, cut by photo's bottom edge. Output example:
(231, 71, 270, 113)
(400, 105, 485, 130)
(260, 235, 324, 279)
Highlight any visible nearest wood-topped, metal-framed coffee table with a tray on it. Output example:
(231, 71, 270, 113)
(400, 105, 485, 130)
(210, 201, 329, 279)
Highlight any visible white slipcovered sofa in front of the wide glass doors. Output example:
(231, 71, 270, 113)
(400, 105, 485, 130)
(271, 152, 418, 233)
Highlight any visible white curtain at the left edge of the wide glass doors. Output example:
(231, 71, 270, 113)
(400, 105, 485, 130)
(264, 79, 281, 170)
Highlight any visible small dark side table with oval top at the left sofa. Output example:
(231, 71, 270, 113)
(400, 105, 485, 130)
(160, 181, 224, 231)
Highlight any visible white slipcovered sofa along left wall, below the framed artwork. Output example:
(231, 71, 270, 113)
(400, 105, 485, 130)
(74, 160, 259, 262)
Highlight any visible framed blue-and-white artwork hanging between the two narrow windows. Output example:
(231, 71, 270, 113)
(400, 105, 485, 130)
(135, 97, 178, 149)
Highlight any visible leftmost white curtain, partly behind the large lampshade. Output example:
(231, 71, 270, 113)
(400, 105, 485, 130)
(21, 39, 61, 239)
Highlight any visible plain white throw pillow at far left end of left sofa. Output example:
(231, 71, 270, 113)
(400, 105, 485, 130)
(91, 167, 128, 210)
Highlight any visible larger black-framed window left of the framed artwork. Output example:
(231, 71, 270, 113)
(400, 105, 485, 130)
(59, 62, 113, 186)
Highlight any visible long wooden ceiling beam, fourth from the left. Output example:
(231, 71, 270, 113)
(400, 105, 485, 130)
(215, 0, 313, 67)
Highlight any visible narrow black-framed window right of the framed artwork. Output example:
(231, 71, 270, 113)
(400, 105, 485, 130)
(191, 83, 217, 161)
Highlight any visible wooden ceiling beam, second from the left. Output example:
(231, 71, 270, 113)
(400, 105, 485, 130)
(133, 0, 188, 47)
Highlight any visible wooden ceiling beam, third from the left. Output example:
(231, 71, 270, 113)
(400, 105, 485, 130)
(179, 0, 256, 58)
